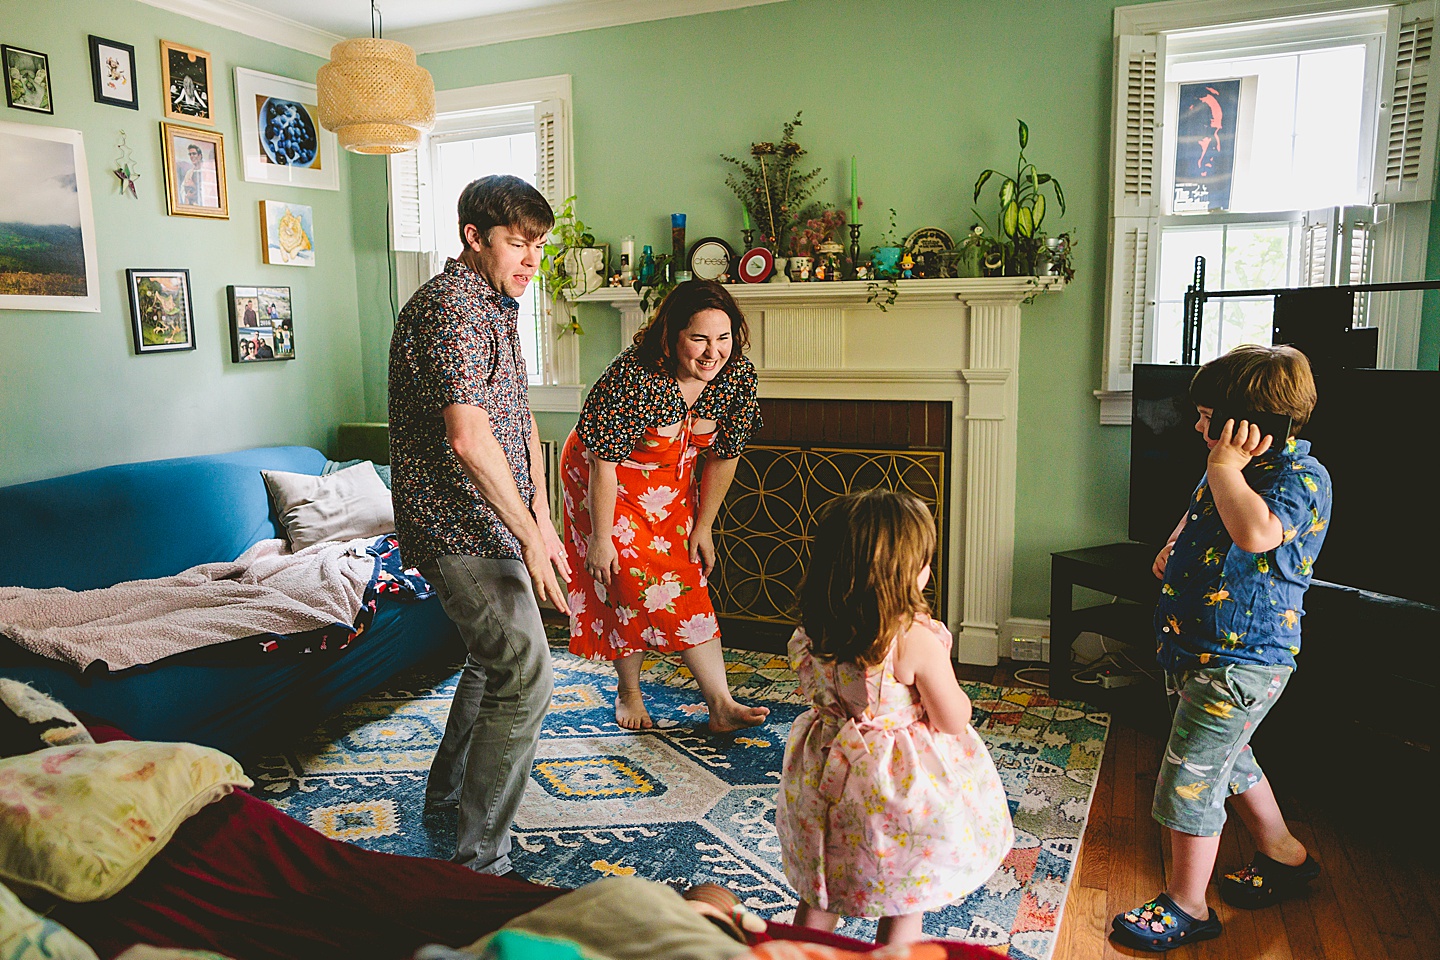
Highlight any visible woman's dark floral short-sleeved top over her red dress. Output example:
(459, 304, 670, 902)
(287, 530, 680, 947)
(576, 347, 763, 463)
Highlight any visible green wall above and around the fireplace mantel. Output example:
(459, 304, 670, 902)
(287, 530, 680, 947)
(342, 0, 1129, 617)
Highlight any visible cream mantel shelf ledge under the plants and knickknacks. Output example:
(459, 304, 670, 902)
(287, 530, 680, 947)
(575, 276, 1066, 308)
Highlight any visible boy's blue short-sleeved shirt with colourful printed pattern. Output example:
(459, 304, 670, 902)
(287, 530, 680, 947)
(1155, 438, 1331, 672)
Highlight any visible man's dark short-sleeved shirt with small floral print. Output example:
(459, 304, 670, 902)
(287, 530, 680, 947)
(390, 259, 536, 566)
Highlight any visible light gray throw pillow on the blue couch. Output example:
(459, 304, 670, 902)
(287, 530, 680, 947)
(261, 461, 395, 550)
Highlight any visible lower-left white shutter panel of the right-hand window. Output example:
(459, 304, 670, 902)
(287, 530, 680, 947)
(1104, 217, 1159, 390)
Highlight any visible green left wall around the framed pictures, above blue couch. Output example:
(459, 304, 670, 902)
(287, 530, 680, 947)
(0, 0, 365, 484)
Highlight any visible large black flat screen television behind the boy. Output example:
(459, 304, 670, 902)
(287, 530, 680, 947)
(1129, 364, 1440, 604)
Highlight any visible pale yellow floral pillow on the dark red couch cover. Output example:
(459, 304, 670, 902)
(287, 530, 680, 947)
(0, 740, 253, 902)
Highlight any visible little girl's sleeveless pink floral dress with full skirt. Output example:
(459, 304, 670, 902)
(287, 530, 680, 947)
(775, 629, 1015, 917)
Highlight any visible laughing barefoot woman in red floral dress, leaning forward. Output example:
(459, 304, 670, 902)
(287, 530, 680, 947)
(560, 281, 769, 733)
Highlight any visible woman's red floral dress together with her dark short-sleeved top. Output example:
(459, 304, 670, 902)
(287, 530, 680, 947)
(560, 351, 759, 661)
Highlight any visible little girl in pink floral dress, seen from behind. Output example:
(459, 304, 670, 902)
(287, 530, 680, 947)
(775, 489, 1015, 943)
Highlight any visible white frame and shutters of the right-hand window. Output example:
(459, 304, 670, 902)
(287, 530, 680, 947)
(1094, 0, 1440, 425)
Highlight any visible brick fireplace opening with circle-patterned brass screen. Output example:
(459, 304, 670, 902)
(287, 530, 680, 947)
(710, 397, 952, 652)
